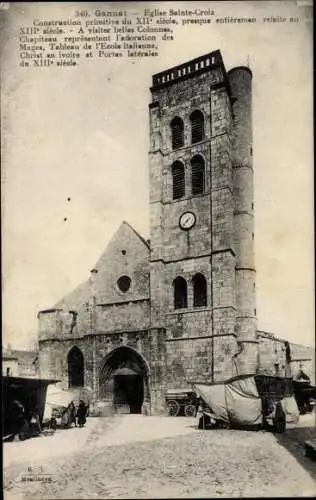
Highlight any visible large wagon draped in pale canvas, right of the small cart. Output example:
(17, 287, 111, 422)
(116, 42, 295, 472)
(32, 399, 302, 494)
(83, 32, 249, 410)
(193, 375, 299, 432)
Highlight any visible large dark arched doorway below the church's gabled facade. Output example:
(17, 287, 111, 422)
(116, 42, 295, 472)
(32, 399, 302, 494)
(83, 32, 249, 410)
(99, 346, 149, 413)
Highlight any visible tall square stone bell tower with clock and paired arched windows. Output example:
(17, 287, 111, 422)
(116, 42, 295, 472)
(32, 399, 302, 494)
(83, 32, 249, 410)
(149, 50, 257, 410)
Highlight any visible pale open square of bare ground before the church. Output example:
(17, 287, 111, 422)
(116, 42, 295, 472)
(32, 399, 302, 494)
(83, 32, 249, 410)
(4, 415, 316, 500)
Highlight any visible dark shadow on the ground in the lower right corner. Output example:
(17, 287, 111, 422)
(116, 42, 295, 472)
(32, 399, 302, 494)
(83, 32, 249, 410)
(275, 426, 316, 481)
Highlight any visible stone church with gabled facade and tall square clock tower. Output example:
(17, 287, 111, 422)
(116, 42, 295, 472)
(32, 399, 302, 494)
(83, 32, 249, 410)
(38, 50, 310, 414)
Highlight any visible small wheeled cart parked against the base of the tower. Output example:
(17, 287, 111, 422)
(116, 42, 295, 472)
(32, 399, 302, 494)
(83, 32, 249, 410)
(166, 389, 198, 417)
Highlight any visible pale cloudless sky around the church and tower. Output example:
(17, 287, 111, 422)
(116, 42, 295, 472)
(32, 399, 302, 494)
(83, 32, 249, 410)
(1, 1, 314, 348)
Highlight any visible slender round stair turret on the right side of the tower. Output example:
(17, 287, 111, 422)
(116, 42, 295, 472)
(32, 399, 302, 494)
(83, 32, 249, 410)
(228, 67, 258, 373)
